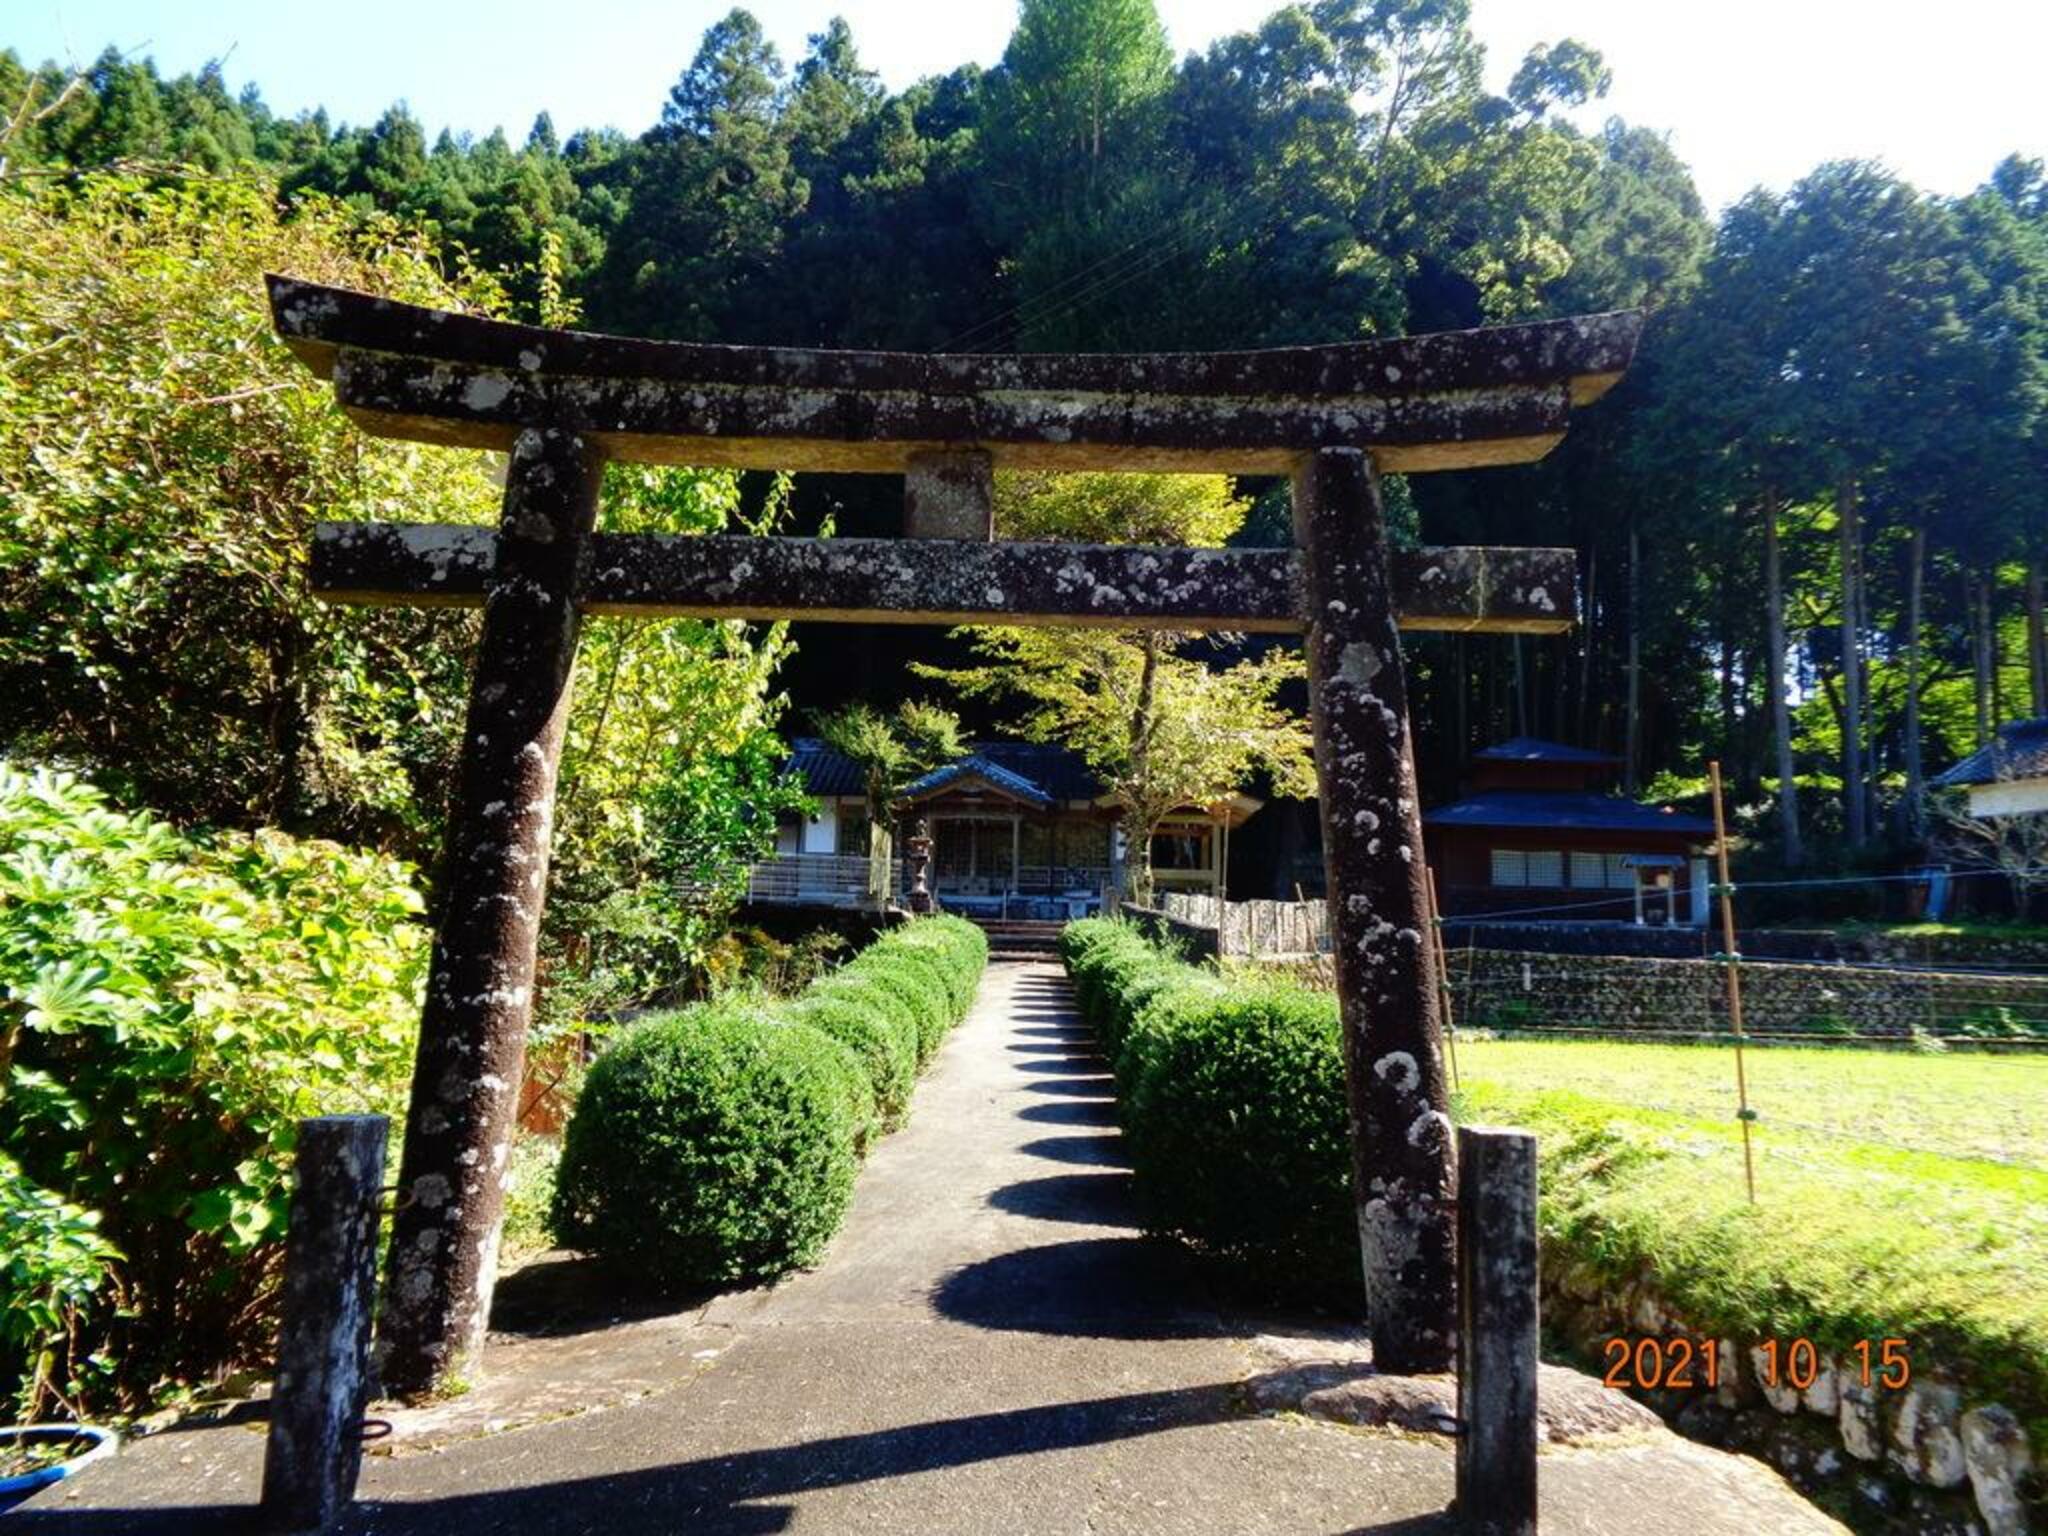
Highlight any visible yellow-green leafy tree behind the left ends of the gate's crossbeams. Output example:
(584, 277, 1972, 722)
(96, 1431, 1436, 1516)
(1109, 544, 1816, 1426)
(0, 178, 498, 862)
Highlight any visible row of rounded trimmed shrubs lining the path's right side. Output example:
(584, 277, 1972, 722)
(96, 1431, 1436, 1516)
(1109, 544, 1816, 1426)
(1061, 918, 1360, 1300)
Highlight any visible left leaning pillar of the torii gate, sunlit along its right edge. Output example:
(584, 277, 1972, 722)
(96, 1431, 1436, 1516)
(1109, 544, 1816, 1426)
(377, 430, 602, 1395)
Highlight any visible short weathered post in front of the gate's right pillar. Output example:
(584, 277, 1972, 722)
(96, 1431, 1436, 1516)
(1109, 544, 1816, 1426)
(1454, 1126, 1536, 1536)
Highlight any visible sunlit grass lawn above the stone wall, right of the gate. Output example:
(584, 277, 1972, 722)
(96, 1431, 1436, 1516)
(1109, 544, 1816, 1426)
(1458, 1040, 2048, 1434)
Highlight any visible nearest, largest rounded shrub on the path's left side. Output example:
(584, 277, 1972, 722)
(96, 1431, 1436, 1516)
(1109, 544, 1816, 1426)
(549, 1008, 870, 1290)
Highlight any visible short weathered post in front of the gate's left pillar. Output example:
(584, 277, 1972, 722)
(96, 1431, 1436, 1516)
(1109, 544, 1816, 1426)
(262, 1114, 391, 1534)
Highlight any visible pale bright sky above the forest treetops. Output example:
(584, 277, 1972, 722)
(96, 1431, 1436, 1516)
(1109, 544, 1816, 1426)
(0, 0, 2048, 207)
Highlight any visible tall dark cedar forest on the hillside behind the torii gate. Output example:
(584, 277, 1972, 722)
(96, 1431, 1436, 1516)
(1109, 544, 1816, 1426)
(0, 0, 2048, 888)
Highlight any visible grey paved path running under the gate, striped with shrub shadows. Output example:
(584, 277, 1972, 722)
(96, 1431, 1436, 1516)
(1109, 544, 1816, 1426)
(8, 965, 1839, 1536)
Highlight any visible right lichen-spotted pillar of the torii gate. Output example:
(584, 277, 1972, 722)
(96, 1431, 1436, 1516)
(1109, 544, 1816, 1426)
(1294, 449, 1456, 1372)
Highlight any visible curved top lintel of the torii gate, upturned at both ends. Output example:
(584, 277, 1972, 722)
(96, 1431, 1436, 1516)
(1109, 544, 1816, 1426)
(268, 276, 1642, 473)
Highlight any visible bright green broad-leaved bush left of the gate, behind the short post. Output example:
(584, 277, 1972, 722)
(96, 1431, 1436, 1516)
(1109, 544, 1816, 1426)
(0, 762, 428, 1397)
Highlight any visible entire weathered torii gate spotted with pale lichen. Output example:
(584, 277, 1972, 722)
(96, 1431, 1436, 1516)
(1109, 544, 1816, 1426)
(270, 276, 1640, 1393)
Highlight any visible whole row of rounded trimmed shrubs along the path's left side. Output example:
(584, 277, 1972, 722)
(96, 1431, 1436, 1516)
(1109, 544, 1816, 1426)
(549, 918, 987, 1290)
